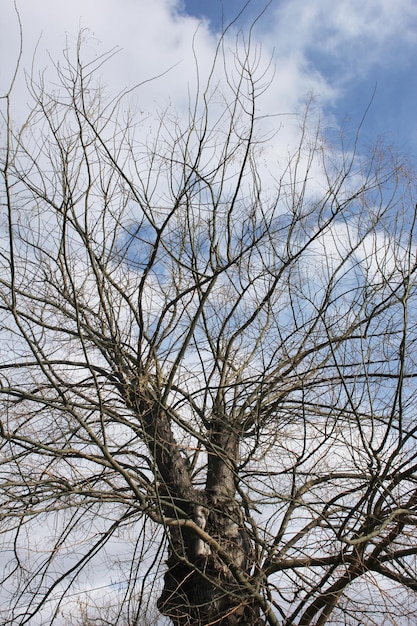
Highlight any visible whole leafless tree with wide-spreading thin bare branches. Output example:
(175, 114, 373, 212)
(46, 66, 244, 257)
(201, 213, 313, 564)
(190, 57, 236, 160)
(0, 14, 417, 626)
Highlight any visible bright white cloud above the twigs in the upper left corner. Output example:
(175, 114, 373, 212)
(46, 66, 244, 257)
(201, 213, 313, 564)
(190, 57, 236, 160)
(0, 0, 214, 107)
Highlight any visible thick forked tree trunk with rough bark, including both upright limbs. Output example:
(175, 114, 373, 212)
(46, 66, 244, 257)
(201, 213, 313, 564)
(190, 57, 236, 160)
(127, 383, 265, 626)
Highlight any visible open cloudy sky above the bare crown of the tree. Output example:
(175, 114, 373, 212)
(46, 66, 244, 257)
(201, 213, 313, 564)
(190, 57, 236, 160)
(0, 0, 417, 163)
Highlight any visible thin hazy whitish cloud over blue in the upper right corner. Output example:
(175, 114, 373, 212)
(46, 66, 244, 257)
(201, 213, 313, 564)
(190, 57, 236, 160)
(271, 0, 417, 80)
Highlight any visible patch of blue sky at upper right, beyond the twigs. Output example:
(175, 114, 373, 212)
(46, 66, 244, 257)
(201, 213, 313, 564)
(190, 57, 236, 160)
(183, 0, 417, 160)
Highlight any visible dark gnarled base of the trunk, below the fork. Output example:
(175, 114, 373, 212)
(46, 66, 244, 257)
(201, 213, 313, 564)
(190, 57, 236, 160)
(158, 501, 265, 626)
